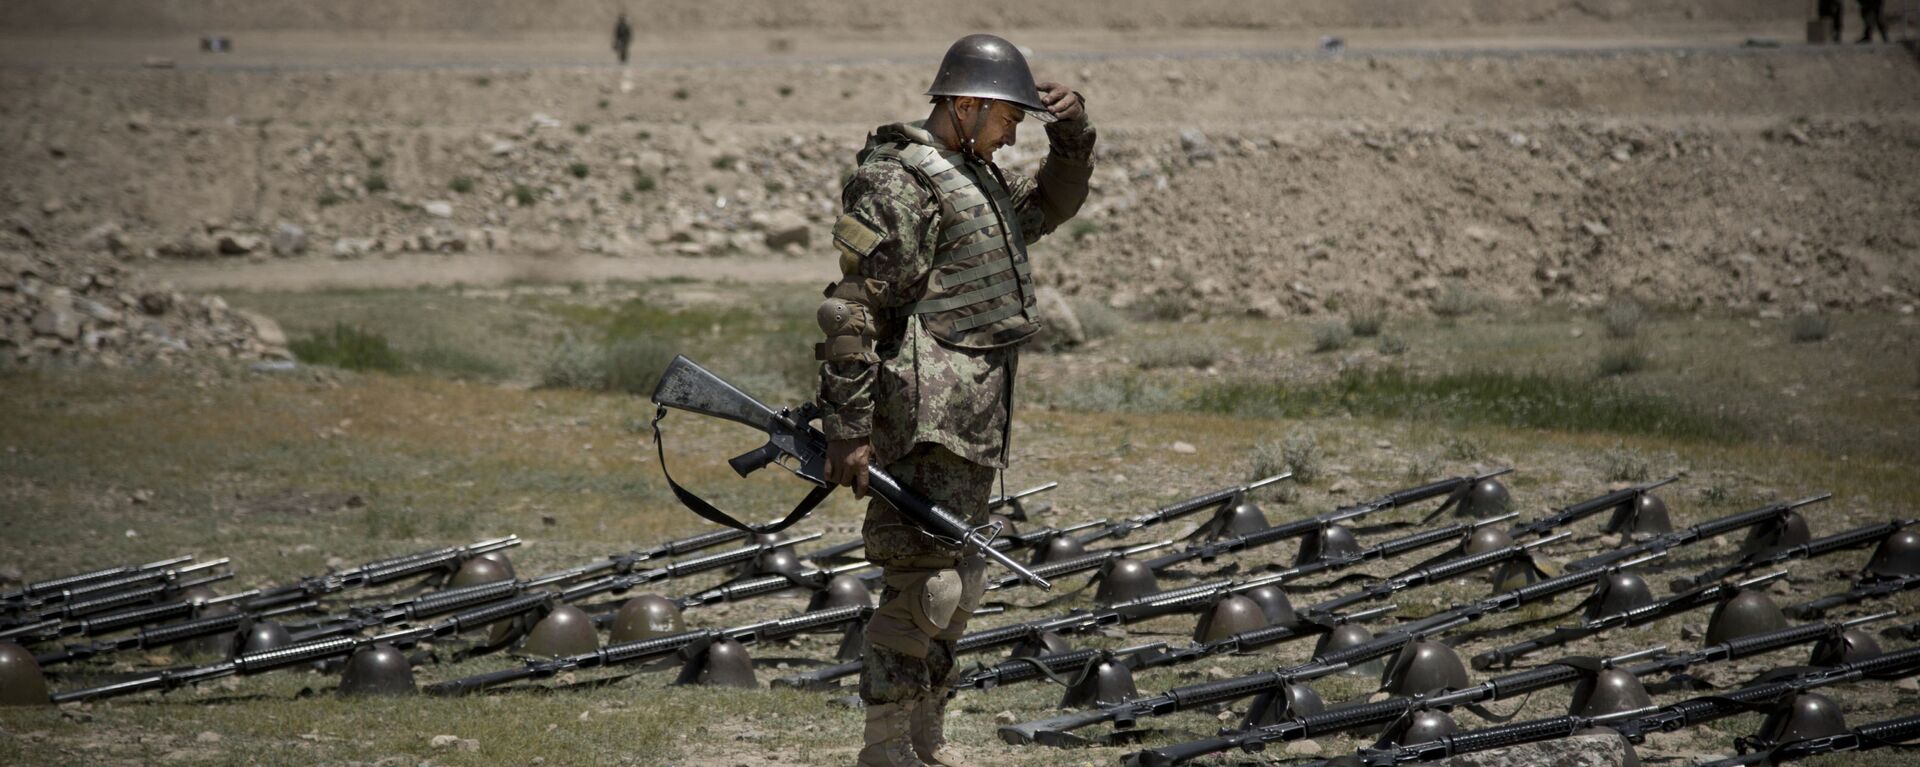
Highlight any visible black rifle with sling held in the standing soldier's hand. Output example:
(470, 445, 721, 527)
(653, 356, 1052, 590)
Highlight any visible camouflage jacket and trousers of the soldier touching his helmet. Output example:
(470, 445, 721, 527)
(820, 119, 1094, 718)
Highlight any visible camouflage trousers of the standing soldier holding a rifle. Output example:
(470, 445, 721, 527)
(860, 444, 993, 704)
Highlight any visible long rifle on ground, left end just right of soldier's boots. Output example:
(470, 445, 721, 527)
(1000, 554, 1663, 746)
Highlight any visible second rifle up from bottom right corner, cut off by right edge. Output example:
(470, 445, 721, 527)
(1309, 648, 1920, 767)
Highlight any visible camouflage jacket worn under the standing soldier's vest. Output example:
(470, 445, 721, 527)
(820, 119, 1094, 469)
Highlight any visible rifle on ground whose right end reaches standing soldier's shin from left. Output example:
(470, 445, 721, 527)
(422, 606, 874, 696)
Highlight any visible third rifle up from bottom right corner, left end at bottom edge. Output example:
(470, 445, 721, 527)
(1125, 613, 1895, 767)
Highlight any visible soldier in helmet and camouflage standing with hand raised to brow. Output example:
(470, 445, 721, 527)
(816, 35, 1094, 767)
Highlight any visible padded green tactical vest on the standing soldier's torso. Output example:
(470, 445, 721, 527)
(860, 142, 1041, 350)
